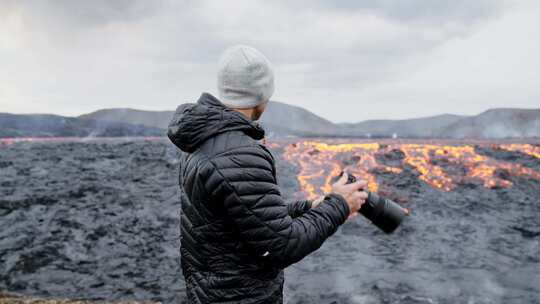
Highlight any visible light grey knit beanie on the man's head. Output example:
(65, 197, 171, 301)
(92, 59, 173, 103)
(218, 45, 274, 109)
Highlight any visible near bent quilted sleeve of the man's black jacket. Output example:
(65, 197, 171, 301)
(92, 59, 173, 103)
(207, 146, 349, 268)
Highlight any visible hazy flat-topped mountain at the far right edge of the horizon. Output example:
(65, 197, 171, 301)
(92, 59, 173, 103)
(435, 109, 540, 138)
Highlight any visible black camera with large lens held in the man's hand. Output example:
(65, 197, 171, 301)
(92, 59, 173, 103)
(340, 172, 409, 233)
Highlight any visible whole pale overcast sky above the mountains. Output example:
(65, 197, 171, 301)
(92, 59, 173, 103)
(0, 0, 540, 122)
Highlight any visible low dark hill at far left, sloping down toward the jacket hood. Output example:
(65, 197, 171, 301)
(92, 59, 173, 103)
(0, 113, 164, 138)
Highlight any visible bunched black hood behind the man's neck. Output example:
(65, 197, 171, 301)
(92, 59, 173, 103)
(167, 93, 264, 153)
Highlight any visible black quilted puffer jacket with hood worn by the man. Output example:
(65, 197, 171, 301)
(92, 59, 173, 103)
(168, 93, 349, 303)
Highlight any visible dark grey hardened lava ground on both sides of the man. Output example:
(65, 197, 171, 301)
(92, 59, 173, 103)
(0, 141, 540, 303)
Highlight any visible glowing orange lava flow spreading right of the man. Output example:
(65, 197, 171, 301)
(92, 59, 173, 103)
(283, 141, 540, 199)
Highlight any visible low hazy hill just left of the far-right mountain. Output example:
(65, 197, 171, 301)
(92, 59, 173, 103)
(341, 114, 466, 137)
